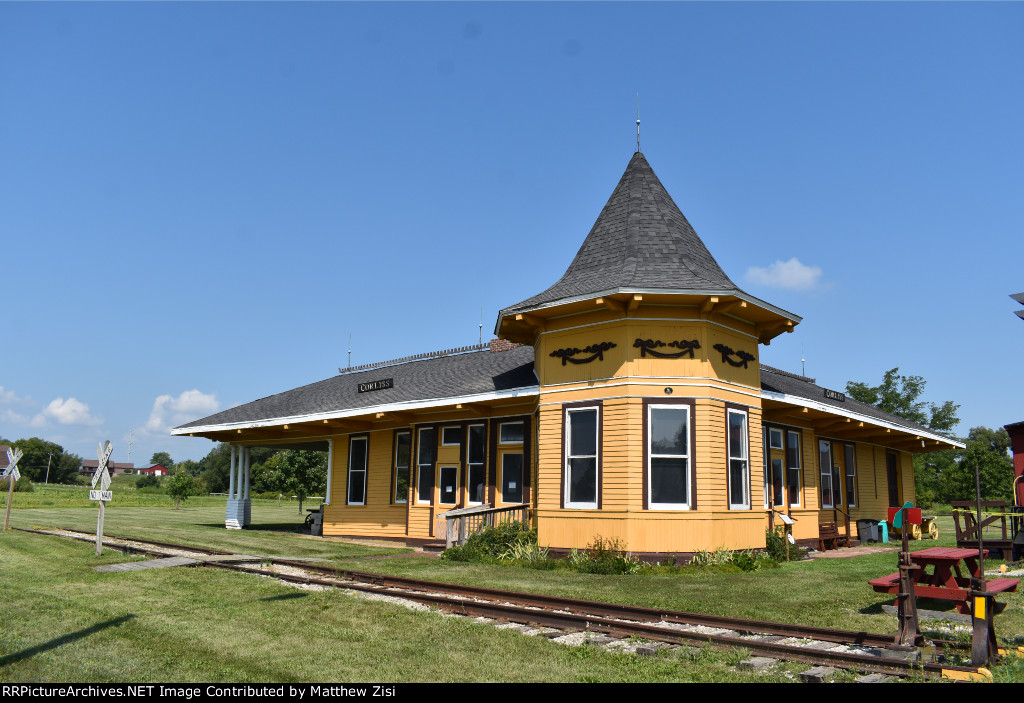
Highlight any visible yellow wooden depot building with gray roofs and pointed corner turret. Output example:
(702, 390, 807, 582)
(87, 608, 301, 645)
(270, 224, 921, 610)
(173, 151, 963, 555)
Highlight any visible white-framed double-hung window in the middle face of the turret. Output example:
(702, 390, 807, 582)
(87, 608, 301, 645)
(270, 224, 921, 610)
(646, 404, 690, 511)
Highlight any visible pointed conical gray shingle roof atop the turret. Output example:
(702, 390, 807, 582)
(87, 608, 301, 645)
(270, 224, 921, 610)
(500, 151, 738, 317)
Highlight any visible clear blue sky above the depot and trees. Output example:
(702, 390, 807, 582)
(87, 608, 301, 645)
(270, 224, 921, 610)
(0, 2, 1024, 464)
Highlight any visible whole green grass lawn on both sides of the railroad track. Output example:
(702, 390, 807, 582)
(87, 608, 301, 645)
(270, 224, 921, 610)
(0, 503, 1024, 682)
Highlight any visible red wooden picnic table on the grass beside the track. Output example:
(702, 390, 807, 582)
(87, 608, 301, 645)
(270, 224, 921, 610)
(868, 546, 1020, 614)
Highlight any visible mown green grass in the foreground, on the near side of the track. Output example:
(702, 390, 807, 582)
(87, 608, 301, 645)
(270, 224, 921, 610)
(0, 531, 806, 683)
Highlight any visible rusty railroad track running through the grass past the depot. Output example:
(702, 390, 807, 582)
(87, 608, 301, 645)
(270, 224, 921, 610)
(14, 528, 991, 678)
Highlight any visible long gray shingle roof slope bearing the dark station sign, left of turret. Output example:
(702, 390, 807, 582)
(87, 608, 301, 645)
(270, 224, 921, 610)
(175, 346, 537, 431)
